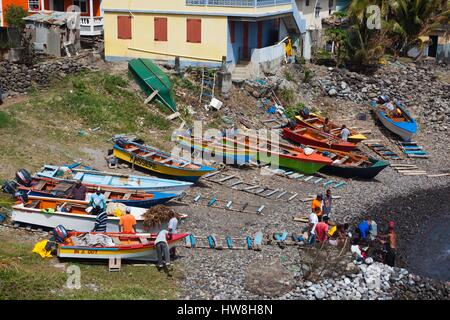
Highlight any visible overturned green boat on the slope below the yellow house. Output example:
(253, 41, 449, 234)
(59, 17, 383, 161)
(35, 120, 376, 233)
(128, 59, 177, 112)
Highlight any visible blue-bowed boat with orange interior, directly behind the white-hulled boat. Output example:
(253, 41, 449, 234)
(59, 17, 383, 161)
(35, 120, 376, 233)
(18, 177, 177, 208)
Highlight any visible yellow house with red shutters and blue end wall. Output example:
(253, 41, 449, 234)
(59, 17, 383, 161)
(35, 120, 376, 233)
(103, 0, 306, 72)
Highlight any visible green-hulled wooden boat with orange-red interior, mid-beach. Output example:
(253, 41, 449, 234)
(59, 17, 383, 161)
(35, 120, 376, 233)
(221, 136, 332, 174)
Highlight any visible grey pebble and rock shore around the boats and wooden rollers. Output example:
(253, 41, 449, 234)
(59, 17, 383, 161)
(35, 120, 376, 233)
(174, 59, 450, 299)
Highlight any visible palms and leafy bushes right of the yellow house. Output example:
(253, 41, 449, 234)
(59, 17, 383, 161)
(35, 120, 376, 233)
(334, 0, 450, 68)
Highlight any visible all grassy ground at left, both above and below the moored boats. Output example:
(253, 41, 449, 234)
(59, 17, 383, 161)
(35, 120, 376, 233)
(0, 72, 188, 300)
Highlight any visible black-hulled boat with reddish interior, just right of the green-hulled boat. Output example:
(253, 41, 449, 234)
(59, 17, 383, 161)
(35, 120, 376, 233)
(314, 147, 389, 179)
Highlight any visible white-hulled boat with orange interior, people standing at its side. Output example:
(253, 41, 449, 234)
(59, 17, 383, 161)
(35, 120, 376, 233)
(12, 196, 159, 232)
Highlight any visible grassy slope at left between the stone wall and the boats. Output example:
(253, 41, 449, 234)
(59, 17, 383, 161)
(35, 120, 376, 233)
(0, 72, 174, 179)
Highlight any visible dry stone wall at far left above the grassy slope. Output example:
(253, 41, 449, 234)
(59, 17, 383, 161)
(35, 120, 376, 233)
(0, 52, 92, 98)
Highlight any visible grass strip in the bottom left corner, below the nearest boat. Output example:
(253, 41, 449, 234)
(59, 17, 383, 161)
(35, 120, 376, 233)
(0, 235, 181, 300)
